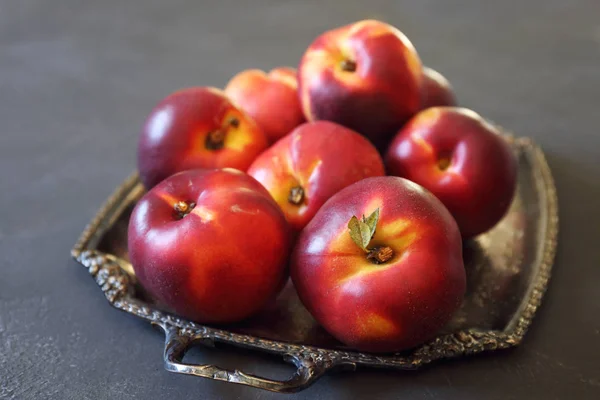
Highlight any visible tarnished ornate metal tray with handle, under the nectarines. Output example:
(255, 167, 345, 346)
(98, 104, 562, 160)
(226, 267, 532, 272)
(71, 135, 558, 392)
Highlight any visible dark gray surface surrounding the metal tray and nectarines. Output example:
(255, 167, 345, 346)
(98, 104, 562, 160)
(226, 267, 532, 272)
(0, 0, 600, 399)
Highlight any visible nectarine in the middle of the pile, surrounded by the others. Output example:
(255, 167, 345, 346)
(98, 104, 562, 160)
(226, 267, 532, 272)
(248, 121, 385, 231)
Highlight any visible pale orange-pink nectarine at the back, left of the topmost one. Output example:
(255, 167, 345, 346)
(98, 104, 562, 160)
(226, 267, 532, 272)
(225, 67, 306, 143)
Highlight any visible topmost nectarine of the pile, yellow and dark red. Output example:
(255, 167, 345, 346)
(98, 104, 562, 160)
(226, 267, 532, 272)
(298, 20, 422, 145)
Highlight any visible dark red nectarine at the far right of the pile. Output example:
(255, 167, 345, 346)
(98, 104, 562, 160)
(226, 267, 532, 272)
(385, 107, 517, 238)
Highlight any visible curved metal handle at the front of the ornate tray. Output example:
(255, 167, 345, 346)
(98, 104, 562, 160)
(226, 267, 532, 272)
(160, 325, 332, 393)
